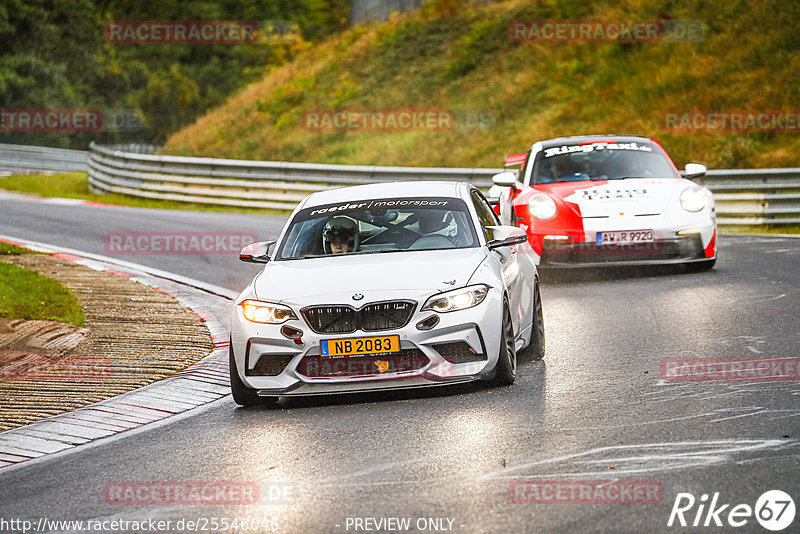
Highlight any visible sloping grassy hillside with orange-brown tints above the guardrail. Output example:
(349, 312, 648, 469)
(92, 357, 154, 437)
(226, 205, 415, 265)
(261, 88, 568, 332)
(165, 0, 800, 169)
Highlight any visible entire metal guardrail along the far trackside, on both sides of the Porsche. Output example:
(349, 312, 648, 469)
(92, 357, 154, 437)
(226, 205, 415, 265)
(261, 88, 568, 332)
(0, 143, 788, 226)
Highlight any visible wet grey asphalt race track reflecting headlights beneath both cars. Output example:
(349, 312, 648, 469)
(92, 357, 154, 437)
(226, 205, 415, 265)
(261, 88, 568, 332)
(0, 195, 800, 533)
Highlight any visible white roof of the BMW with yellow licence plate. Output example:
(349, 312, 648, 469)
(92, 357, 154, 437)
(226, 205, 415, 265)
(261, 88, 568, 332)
(302, 180, 470, 208)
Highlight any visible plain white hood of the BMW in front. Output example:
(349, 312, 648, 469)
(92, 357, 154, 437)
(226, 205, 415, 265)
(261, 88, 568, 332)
(254, 247, 486, 304)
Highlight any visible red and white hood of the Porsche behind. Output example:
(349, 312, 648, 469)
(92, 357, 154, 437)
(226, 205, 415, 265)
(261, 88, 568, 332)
(538, 178, 687, 217)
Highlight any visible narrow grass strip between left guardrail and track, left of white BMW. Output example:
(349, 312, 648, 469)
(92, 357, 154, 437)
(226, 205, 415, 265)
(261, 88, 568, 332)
(0, 172, 283, 215)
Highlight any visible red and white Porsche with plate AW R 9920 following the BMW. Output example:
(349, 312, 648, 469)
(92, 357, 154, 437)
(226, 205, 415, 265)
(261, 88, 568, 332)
(490, 135, 717, 270)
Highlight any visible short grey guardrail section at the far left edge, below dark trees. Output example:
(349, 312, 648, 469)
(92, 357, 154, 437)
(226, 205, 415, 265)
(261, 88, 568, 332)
(0, 143, 89, 174)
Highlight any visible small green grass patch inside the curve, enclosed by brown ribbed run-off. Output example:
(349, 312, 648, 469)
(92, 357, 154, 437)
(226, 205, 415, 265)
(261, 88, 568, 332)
(0, 260, 85, 326)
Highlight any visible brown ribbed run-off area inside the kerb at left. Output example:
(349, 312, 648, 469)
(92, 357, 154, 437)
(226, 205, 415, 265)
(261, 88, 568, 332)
(0, 254, 213, 431)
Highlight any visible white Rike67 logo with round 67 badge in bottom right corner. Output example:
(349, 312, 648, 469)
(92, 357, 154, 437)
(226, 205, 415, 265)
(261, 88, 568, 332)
(667, 490, 795, 532)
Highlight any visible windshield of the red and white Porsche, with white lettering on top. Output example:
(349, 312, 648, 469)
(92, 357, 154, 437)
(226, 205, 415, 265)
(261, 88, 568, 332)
(531, 141, 680, 185)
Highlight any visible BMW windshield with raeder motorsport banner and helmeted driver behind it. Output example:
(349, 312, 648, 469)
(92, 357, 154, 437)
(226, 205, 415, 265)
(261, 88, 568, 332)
(277, 198, 478, 260)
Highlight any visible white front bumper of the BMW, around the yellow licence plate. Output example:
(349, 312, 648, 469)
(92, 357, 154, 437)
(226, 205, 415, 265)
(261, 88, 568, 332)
(231, 290, 502, 397)
